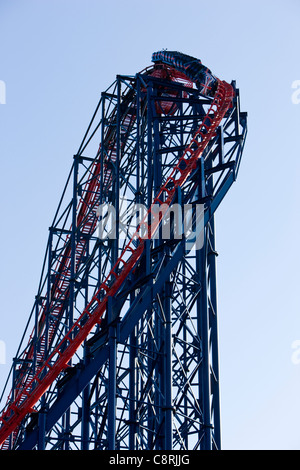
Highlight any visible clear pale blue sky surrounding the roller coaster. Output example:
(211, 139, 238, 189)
(0, 0, 300, 450)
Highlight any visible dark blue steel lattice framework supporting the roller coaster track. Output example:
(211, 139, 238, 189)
(2, 57, 247, 450)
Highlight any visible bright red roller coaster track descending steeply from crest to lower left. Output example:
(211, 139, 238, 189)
(0, 75, 234, 448)
